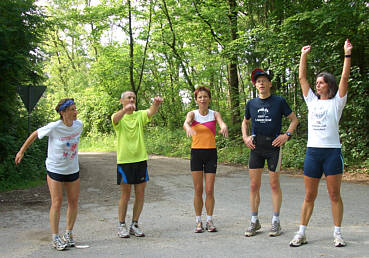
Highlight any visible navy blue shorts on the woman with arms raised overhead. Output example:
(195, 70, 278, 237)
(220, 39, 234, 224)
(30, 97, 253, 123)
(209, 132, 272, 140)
(304, 147, 344, 178)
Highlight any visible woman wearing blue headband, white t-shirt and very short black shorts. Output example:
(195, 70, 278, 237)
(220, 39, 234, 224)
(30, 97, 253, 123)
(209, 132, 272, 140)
(15, 99, 83, 251)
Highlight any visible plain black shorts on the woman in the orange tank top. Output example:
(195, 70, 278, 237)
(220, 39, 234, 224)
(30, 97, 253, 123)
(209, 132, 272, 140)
(191, 149, 218, 173)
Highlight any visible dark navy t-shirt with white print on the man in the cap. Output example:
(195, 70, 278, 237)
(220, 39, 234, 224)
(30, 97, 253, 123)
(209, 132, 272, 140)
(245, 95, 292, 137)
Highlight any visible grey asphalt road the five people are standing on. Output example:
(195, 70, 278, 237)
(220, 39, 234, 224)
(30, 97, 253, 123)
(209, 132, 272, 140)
(0, 153, 369, 258)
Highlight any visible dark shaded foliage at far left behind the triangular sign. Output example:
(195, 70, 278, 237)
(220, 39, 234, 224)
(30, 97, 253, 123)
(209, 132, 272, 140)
(0, 0, 47, 191)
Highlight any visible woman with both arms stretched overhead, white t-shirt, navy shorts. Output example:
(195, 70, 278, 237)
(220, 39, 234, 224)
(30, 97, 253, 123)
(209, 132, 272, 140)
(290, 40, 352, 247)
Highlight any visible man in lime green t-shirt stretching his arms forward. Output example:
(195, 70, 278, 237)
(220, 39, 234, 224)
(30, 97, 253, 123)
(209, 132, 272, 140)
(112, 91, 163, 238)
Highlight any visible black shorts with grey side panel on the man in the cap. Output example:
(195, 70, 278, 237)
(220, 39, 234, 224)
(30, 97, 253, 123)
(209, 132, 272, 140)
(249, 135, 282, 172)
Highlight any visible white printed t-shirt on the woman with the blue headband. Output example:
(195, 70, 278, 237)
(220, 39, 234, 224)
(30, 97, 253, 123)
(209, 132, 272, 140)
(37, 120, 83, 175)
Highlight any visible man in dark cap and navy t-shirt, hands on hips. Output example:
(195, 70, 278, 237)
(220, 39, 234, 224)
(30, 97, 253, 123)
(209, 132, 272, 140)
(242, 69, 298, 237)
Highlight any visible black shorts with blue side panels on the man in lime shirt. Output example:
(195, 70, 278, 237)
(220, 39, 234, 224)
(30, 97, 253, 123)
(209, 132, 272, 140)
(117, 160, 149, 185)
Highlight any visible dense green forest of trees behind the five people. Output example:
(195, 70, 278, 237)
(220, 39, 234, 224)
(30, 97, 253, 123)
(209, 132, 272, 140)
(0, 0, 369, 189)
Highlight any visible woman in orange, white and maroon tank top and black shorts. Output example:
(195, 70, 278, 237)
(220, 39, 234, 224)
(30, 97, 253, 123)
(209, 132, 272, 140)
(183, 87, 228, 233)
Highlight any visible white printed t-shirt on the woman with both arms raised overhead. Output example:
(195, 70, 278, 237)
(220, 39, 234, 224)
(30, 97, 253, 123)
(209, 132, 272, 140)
(304, 89, 347, 148)
